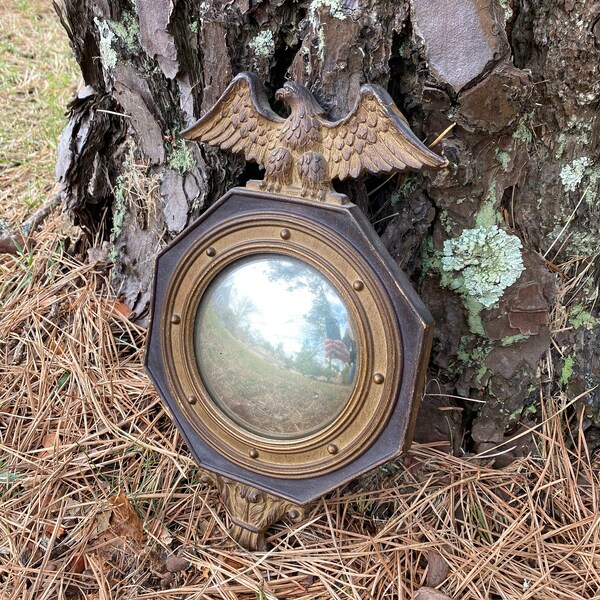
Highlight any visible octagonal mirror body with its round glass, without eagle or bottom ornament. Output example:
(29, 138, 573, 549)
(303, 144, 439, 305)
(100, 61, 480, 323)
(146, 188, 431, 505)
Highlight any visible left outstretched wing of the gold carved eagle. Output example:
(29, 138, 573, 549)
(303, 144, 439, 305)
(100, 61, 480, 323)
(181, 72, 285, 166)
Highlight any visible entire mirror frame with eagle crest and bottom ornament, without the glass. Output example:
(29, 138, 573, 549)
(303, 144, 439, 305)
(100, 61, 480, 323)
(146, 73, 447, 549)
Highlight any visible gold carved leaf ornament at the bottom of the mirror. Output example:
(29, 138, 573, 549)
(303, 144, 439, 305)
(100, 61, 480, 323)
(200, 471, 305, 552)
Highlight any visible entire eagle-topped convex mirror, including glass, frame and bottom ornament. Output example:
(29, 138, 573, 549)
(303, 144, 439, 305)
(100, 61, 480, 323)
(146, 73, 447, 550)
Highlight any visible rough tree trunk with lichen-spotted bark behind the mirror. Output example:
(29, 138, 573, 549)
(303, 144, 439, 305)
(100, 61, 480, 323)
(57, 0, 600, 457)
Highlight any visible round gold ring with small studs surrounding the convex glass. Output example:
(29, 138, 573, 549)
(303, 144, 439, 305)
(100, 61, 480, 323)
(162, 206, 402, 479)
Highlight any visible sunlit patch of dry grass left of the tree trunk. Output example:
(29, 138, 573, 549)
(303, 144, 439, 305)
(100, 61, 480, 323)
(0, 0, 79, 225)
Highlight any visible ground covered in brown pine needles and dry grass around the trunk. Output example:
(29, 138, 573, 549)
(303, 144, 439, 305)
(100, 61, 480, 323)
(0, 2, 600, 600)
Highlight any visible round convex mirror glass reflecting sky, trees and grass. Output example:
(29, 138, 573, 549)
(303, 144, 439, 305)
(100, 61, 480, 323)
(194, 254, 358, 439)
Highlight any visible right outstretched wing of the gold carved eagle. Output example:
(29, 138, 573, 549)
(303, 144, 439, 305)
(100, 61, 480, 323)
(322, 85, 448, 179)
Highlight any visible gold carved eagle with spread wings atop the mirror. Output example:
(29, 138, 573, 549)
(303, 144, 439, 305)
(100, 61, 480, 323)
(182, 72, 448, 202)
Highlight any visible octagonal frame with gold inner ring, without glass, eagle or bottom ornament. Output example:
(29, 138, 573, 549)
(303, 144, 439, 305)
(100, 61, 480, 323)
(146, 188, 432, 505)
